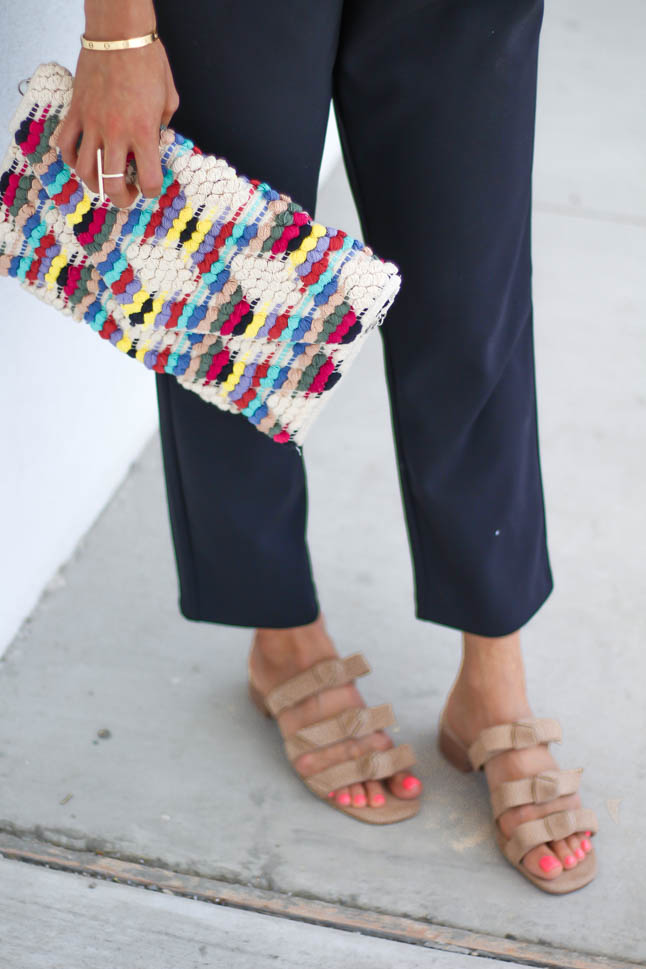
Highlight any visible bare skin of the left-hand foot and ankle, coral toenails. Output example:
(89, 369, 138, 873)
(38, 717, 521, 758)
(249, 614, 422, 807)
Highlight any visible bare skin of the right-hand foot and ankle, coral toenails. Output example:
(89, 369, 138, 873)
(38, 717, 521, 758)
(445, 632, 592, 879)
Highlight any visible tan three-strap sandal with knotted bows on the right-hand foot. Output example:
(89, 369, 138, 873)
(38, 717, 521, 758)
(438, 707, 598, 895)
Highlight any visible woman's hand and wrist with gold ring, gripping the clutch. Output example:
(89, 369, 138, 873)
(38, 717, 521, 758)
(58, 0, 179, 208)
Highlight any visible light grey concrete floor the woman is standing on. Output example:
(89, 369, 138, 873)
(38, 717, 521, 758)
(0, 0, 646, 969)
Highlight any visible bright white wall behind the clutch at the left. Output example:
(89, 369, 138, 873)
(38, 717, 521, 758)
(0, 0, 340, 655)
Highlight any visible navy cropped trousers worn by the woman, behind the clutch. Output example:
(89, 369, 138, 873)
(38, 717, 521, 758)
(156, 0, 553, 636)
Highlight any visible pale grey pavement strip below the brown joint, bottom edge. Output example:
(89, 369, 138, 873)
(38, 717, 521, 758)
(0, 859, 540, 969)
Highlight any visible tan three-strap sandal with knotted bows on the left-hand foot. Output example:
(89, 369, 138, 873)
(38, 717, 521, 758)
(248, 653, 420, 824)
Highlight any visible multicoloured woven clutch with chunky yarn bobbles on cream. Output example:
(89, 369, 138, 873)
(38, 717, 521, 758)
(0, 62, 401, 445)
